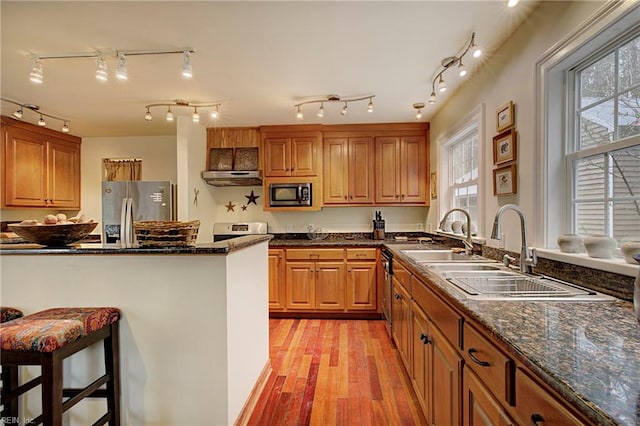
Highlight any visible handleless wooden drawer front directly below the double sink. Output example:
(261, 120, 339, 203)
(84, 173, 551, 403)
(412, 279, 462, 347)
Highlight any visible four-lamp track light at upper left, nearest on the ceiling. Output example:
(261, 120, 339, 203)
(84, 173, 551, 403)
(29, 48, 195, 84)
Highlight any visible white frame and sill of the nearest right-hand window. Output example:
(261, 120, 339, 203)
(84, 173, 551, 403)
(534, 2, 640, 276)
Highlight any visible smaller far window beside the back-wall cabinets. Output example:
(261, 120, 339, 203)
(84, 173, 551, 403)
(438, 105, 482, 230)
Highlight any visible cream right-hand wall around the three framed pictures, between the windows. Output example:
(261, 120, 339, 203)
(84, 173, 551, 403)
(427, 1, 604, 252)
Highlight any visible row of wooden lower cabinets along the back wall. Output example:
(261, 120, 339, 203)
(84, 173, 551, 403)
(269, 248, 378, 313)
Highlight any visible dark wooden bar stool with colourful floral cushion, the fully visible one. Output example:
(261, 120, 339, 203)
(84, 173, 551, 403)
(0, 307, 121, 426)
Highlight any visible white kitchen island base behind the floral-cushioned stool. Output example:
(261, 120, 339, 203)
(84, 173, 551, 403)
(0, 241, 269, 426)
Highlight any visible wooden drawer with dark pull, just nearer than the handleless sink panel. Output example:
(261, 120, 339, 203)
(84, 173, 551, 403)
(463, 323, 515, 405)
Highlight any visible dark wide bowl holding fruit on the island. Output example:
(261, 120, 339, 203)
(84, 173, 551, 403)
(7, 222, 98, 247)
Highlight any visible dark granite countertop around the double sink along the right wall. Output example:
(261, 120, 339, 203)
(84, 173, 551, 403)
(388, 244, 640, 425)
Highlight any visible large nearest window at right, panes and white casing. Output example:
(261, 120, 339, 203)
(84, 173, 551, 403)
(534, 2, 640, 258)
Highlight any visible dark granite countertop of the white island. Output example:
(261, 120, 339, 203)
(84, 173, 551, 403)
(0, 234, 273, 256)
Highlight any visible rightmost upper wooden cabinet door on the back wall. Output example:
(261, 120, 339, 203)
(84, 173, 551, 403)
(398, 136, 427, 203)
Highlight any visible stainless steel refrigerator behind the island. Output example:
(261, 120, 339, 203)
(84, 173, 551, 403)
(102, 181, 176, 247)
